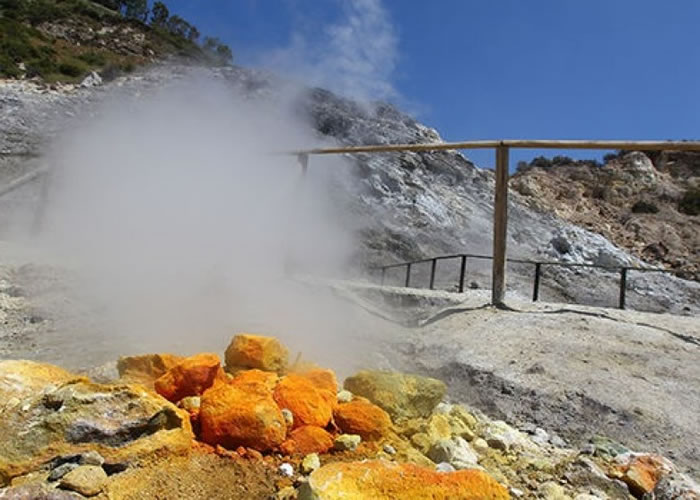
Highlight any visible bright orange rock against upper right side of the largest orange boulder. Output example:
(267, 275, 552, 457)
(274, 374, 333, 428)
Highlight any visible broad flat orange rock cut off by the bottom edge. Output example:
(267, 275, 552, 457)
(300, 460, 510, 500)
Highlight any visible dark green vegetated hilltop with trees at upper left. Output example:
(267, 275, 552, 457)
(0, 0, 233, 82)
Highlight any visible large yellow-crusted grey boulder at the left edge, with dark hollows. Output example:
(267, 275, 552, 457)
(0, 362, 193, 484)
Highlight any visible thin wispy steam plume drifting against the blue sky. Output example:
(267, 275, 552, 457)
(262, 0, 398, 101)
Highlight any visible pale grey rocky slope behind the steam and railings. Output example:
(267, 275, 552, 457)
(0, 64, 700, 313)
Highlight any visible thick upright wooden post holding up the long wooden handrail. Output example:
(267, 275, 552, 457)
(491, 145, 508, 306)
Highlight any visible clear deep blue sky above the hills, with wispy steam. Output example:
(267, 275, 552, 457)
(159, 0, 700, 166)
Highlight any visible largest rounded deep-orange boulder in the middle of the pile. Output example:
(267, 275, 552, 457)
(199, 381, 287, 451)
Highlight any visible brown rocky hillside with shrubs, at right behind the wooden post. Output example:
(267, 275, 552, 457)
(511, 151, 700, 279)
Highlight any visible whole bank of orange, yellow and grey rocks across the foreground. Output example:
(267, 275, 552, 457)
(0, 333, 698, 500)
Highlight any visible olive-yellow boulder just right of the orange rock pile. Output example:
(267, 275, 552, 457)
(343, 371, 447, 420)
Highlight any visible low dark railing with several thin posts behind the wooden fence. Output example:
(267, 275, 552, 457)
(373, 253, 697, 309)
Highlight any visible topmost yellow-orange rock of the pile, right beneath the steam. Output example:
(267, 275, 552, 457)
(225, 333, 289, 373)
